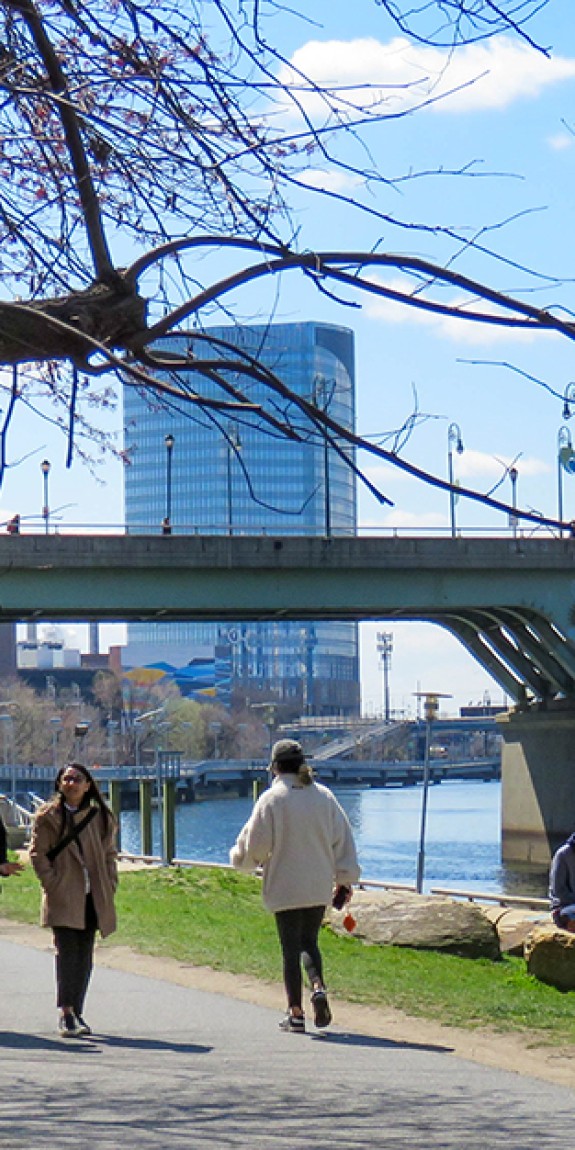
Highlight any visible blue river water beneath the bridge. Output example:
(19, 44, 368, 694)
(122, 782, 547, 897)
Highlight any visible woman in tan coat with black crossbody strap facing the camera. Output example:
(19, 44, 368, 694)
(30, 762, 117, 1037)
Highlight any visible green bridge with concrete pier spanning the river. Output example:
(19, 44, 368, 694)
(0, 535, 575, 865)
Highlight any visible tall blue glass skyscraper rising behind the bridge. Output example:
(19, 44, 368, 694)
(124, 322, 360, 715)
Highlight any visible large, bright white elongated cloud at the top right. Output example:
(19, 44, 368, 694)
(281, 37, 575, 115)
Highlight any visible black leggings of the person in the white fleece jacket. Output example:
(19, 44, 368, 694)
(276, 906, 325, 1007)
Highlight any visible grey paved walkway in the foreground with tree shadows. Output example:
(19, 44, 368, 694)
(0, 941, 575, 1150)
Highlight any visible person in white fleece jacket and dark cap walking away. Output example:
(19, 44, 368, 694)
(230, 738, 360, 1034)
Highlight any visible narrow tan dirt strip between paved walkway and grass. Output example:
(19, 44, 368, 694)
(0, 919, 575, 1089)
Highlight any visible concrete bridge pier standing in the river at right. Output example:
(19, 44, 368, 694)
(497, 703, 575, 867)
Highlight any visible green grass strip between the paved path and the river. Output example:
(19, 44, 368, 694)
(0, 868, 575, 1043)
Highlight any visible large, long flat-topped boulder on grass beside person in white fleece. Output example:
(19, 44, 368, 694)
(329, 890, 501, 959)
